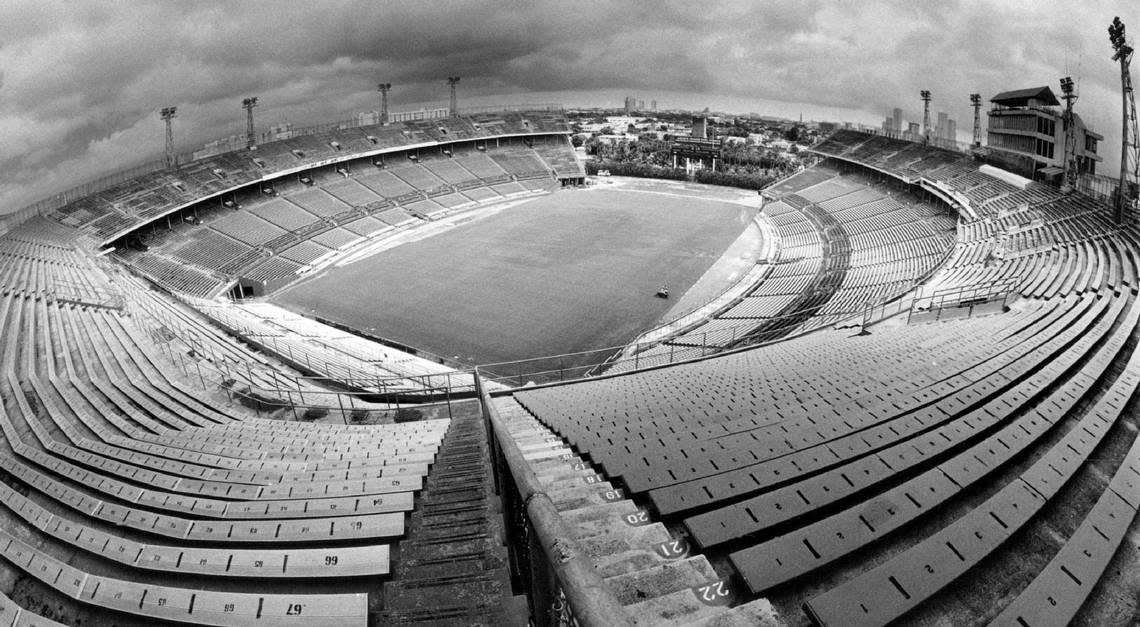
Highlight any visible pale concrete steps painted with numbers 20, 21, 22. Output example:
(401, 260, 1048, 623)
(495, 397, 783, 627)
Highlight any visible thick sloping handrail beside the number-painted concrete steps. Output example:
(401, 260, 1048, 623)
(474, 368, 633, 627)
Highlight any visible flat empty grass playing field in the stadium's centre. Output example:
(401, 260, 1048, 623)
(271, 189, 756, 373)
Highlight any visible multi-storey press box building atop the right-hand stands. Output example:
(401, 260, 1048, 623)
(987, 87, 1104, 180)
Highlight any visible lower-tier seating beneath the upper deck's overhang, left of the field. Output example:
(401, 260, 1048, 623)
(107, 136, 580, 296)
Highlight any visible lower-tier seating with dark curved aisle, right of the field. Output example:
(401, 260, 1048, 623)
(614, 161, 955, 371)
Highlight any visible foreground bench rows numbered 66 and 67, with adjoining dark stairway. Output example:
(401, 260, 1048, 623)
(0, 219, 524, 625)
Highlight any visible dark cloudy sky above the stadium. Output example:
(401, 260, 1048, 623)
(0, 0, 1140, 213)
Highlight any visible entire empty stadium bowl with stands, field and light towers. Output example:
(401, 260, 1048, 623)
(0, 4, 1140, 627)
